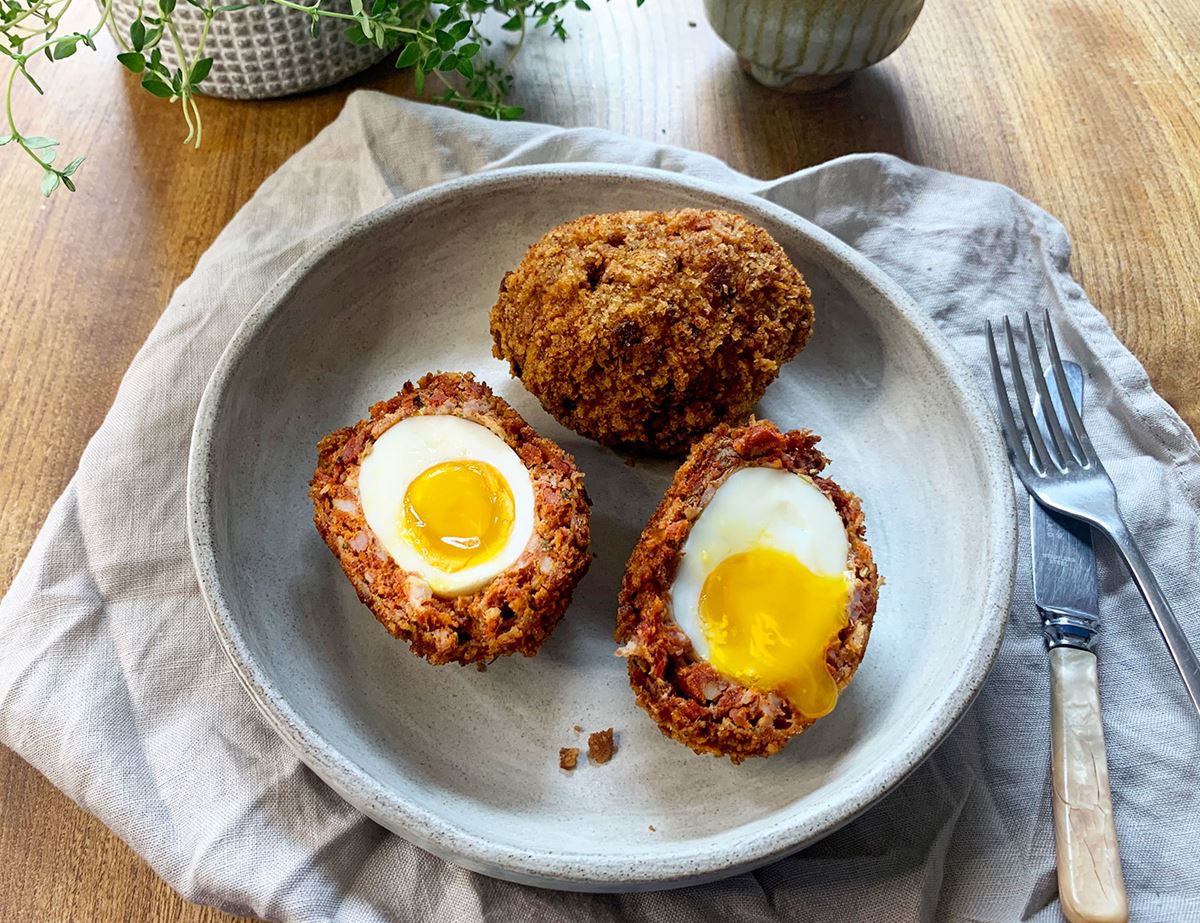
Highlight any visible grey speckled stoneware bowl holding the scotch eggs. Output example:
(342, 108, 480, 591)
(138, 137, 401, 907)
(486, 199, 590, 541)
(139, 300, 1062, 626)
(188, 164, 1015, 891)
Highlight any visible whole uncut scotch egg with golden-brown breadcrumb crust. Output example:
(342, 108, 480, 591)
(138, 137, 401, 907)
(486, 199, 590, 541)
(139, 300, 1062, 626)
(491, 209, 812, 454)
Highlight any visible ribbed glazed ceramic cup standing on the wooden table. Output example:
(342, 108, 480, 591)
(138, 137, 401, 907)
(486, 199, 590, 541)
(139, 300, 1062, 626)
(704, 0, 925, 92)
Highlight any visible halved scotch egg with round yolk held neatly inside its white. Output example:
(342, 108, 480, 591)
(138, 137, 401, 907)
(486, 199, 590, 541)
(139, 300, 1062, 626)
(310, 372, 590, 664)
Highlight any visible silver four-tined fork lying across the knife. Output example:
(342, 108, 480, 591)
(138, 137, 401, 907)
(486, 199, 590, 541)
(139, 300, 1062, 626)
(986, 311, 1200, 713)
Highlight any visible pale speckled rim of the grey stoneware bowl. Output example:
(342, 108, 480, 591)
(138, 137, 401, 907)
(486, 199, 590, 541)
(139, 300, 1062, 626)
(187, 163, 1016, 891)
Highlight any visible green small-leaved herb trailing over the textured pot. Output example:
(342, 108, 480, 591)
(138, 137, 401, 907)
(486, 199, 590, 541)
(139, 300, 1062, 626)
(0, 0, 644, 196)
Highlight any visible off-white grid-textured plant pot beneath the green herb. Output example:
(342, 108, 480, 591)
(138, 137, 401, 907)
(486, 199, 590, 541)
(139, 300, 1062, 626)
(105, 0, 384, 100)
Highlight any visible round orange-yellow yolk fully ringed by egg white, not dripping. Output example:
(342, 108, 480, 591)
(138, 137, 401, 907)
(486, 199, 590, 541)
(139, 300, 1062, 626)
(400, 461, 514, 574)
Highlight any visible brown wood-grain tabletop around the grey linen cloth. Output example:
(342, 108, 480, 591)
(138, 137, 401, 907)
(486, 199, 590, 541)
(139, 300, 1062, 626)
(0, 0, 1200, 922)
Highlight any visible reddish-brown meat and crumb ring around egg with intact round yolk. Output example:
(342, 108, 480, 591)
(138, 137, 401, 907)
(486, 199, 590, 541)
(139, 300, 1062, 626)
(310, 372, 590, 664)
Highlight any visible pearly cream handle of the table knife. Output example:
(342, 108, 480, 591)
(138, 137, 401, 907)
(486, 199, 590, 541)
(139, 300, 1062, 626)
(1050, 647, 1129, 923)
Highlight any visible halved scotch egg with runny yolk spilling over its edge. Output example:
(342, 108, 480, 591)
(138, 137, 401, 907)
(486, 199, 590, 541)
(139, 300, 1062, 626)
(617, 420, 880, 763)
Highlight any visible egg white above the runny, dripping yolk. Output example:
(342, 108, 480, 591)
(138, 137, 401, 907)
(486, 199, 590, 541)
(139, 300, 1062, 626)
(670, 468, 852, 660)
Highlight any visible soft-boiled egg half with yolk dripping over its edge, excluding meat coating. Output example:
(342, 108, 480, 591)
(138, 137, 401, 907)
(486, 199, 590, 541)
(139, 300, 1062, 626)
(670, 467, 853, 718)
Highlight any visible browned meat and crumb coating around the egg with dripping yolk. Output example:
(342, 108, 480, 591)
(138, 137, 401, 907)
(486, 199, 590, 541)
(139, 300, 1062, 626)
(617, 420, 880, 763)
